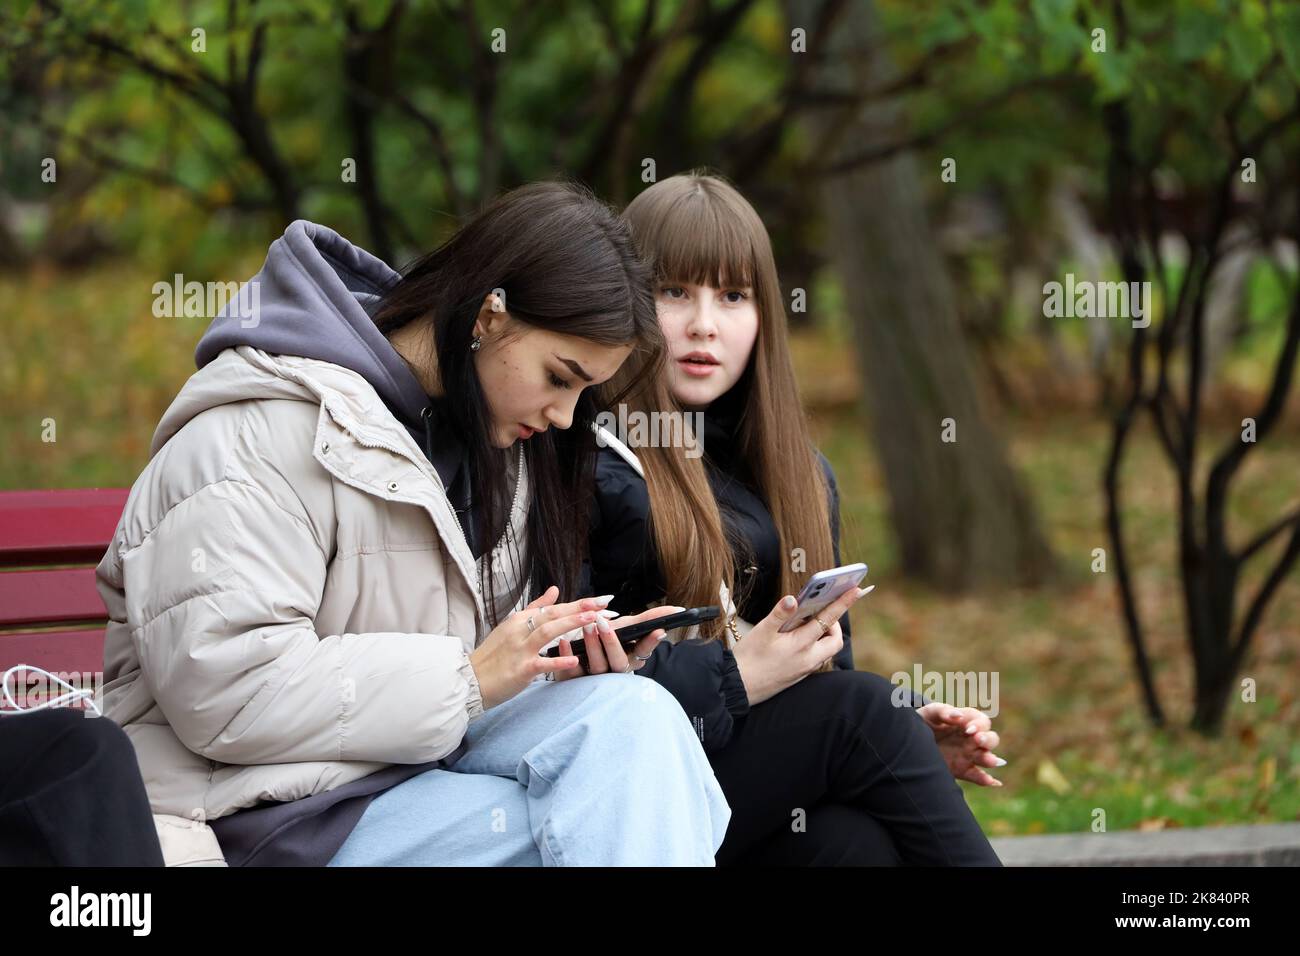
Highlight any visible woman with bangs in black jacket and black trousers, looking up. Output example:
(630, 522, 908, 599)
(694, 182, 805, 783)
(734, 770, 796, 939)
(560, 174, 1004, 865)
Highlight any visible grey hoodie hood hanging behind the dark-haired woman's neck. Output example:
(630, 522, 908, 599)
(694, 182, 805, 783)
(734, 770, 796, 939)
(194, 219, 430, 433)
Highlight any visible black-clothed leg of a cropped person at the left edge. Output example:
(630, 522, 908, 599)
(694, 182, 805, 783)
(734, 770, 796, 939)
(0, 708, 163, 866)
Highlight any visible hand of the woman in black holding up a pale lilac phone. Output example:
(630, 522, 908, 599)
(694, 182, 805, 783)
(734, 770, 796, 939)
(732, 588, 867, 706)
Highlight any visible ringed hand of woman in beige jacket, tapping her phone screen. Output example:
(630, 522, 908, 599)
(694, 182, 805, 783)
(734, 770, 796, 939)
(469, 584, 610, 710)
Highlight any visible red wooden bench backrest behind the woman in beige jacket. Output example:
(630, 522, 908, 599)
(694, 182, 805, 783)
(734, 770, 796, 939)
(0, 488, 129, 709)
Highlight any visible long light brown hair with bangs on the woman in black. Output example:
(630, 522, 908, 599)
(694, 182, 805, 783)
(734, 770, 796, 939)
(611, 170, 835, 636)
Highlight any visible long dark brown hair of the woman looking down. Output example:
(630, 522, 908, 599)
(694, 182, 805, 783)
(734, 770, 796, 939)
(374, 182, 664, 626)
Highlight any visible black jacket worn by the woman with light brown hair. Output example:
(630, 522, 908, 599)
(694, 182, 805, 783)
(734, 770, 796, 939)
(582, 397, 853, 753)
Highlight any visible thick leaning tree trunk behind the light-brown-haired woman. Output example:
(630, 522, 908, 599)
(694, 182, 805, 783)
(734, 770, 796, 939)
(790, 0, 1052, 589)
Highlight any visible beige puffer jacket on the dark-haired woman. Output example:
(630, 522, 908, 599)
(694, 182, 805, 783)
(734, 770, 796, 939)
(96, 346, 529, 865)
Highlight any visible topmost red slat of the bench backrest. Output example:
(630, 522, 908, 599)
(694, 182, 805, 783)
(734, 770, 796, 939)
(0, 488, 130, 567)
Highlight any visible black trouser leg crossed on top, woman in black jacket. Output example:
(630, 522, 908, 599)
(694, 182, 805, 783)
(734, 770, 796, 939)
(712, 671, 1000, 866)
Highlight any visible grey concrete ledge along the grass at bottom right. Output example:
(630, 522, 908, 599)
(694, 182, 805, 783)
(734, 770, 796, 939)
(989, 823, 1300, 866)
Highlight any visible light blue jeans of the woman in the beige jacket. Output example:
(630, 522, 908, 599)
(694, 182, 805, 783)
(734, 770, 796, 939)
(329, 674, 731, 866)
